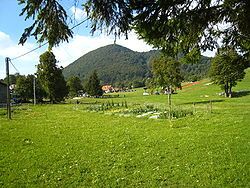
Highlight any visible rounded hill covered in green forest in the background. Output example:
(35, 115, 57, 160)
(63, 44, 210, 84)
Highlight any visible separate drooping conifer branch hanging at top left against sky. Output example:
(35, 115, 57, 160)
(19, 0, 73, 49)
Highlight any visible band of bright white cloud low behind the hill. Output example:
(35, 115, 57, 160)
(0, 31, 152, 78)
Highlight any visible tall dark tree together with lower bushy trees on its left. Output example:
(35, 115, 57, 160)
(10, 51, 68, 103)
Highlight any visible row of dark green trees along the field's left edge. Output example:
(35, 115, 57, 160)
(10, 51, 102, 103)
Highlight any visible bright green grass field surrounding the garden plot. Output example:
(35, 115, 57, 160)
(0, 69, 250, 187)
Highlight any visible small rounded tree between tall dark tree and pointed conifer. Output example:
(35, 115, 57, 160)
(67, 76, 83, 97)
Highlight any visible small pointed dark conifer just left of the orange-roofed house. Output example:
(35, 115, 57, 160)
(85, 71, 103, 96)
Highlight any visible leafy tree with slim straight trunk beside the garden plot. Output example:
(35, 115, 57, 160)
(151, 55, 183, 106)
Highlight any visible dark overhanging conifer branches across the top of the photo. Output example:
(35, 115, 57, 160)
(19, 0, 250, 54)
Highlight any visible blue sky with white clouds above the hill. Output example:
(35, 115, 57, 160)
(0, 0, 213, 79)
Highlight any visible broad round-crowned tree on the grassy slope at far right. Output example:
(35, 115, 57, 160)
(209, 48, 249, 97)
